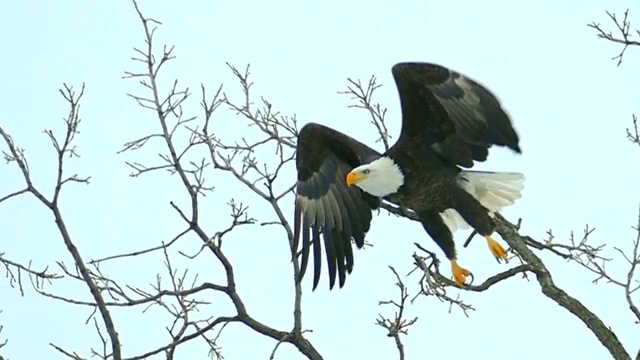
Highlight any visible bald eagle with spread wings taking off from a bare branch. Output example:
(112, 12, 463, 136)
(293, 63, 525, 290)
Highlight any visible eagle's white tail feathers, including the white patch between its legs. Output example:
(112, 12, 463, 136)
(440, 170, 525, 232)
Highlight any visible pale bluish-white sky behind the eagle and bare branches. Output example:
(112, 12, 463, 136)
(0, 0, 640, 360)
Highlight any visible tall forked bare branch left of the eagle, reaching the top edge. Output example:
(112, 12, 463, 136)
(118, 2, 322, 359)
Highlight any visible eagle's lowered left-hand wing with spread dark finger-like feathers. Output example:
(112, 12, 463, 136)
(293, 123, 380, 290)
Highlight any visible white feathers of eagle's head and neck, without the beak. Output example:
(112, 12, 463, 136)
(358, 156, 404, 197)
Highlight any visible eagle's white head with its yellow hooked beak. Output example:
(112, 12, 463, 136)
(347, 156, 404, 197)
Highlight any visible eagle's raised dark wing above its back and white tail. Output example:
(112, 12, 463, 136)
(392, 63, 521, 167)
